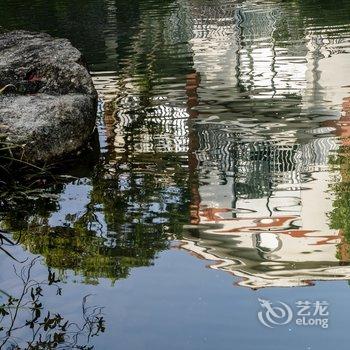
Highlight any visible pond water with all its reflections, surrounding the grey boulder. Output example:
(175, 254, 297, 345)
(0, 0, 350, 350)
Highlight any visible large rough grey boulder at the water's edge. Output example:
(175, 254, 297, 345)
(0, 31, 97, 162)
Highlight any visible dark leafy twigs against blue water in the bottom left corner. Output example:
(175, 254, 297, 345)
(0, 258, 105, 350)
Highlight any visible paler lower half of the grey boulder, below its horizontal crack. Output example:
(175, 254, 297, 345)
(0, 94, 95, 161)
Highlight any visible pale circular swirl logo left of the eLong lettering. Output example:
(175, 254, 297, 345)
(258, 299, 293, 328)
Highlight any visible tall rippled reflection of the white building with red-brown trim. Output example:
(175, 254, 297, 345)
(181, 4, 350, 288)
